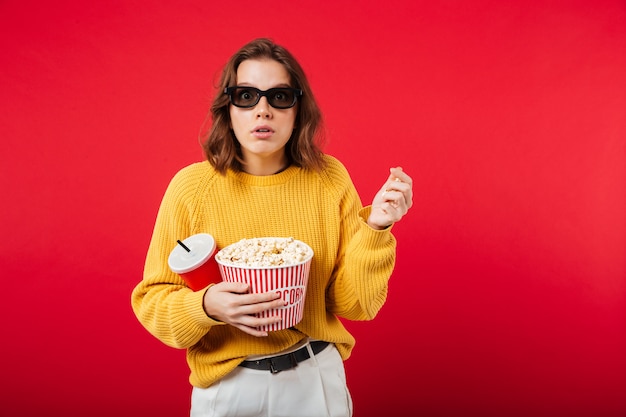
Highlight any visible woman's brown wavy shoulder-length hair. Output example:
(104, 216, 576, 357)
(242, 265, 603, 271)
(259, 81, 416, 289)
(200, 38, 324, 174)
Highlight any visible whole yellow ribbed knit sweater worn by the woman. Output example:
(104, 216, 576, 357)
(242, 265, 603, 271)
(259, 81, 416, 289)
(132, 156, 396, 387)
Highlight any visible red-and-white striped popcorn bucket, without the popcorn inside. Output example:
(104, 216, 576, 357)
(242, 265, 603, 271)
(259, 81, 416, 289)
(216, 242, 313, 331)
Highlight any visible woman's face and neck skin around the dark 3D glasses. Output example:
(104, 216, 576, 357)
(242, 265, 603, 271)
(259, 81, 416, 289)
(229, 59, 297, 169)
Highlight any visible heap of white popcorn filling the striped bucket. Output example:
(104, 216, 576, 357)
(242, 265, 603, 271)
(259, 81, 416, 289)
(215, 237, 312, 268)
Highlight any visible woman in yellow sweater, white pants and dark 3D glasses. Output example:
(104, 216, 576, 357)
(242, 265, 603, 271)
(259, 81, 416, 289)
(132, 39, 412, 417)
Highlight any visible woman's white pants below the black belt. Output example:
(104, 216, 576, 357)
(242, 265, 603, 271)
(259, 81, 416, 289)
(190, 344, 352, 417)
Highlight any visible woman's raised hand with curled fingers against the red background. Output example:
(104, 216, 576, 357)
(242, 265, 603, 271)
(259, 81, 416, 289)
(367, 167, 413, 230)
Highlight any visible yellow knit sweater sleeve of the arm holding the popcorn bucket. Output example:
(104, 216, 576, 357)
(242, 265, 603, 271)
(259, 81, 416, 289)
(131, 165, 222, 348)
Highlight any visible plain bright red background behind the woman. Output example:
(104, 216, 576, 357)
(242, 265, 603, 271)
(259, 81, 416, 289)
(0, 0, 626, 417)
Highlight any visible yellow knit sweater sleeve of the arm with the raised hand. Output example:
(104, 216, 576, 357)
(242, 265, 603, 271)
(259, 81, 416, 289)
(326, 158, 396, 320)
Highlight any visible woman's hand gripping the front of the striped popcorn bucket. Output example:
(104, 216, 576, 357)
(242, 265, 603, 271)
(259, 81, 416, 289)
(203, 282, 286, 337)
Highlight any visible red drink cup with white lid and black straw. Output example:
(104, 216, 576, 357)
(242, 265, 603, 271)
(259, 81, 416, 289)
(167, 233, 222, 291)
